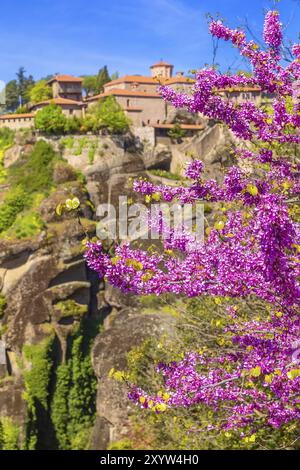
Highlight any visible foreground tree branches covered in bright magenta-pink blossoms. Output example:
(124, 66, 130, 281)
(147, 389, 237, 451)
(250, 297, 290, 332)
(86, 11, 300, 442)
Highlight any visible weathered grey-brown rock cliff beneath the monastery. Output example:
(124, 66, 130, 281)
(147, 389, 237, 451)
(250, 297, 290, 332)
(0, 127, 232, 449)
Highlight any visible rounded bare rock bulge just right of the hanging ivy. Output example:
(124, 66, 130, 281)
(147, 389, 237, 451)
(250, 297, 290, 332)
(92, 308, 175, 450)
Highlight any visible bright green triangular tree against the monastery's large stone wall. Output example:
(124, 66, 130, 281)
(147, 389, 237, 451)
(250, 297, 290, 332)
(83, 96, 130, 134)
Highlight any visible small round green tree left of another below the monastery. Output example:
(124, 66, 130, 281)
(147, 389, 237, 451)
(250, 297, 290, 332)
(34, 103, 67, 134)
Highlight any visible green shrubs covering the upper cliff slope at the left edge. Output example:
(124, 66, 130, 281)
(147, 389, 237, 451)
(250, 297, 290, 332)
(0, 140, 83, 238)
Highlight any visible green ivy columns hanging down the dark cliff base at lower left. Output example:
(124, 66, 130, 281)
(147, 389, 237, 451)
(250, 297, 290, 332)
(0, 317, 99, 450)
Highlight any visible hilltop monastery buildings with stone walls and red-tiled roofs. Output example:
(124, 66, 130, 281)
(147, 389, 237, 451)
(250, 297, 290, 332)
(0, 60, 267, 133)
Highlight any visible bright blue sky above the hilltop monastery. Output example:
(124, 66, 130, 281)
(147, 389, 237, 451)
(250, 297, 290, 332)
(0, 0, 300, 82)
